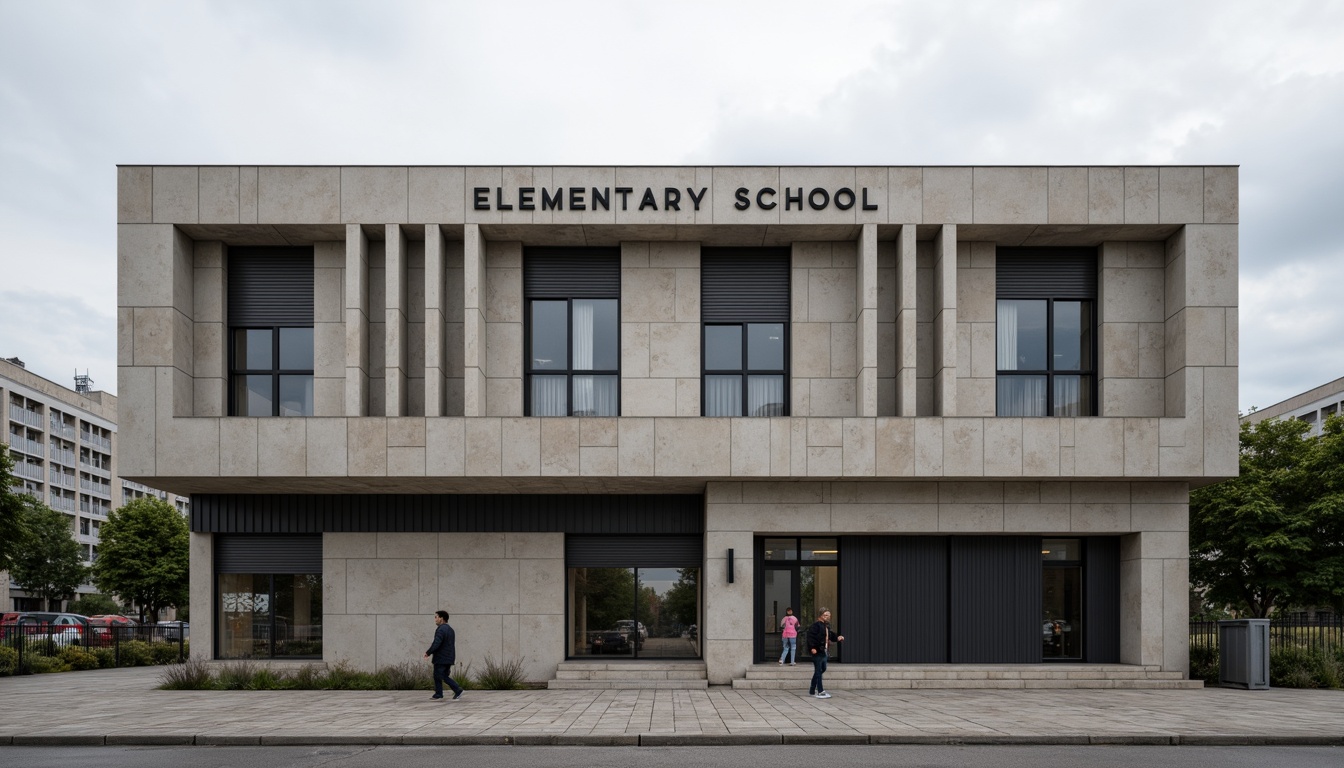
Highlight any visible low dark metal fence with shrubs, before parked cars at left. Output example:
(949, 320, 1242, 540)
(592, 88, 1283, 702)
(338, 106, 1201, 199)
(0, 621, 191, 674)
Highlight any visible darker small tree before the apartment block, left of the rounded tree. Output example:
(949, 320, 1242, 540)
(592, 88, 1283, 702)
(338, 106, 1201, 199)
(11, 505, 89, 608)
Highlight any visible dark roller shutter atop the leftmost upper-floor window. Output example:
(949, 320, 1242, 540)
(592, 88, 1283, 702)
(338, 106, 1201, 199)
(228, 247, 313, 328)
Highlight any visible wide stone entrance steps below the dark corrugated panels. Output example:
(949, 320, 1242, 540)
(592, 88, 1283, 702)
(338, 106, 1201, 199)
(732, 662, 1204, 691)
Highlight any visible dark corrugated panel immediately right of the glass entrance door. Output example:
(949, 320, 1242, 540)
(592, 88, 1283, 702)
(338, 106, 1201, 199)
(837, 537, 948, 664)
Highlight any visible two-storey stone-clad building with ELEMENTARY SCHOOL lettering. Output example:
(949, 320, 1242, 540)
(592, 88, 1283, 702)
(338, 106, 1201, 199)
(118, 165, 1238, 687)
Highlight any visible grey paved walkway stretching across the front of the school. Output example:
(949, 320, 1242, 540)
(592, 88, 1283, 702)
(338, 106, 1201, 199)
(0, 667, 1344, 745)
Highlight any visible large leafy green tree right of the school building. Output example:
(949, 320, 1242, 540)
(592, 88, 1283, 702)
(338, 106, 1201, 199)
(1189, 418, 1344, 617)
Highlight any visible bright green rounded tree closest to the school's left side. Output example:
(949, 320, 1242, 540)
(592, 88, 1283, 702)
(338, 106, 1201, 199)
(93, 498, 191, 621)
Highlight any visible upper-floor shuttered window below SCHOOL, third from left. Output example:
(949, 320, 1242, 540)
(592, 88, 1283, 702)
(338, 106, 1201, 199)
(700, 249, 790, 417)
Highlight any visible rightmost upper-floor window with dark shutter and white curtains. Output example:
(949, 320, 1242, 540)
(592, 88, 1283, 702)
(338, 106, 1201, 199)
(996, 249, 1097, 417)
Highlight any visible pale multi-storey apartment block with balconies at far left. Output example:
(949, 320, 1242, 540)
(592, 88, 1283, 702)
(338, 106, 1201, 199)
(0, 358, 190, 611)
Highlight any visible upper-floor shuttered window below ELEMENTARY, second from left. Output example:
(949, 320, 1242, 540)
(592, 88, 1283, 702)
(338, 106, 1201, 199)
(523, 249, 621, 416)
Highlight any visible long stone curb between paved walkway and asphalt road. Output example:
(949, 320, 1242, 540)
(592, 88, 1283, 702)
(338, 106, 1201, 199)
(0, 733, 1344, 748)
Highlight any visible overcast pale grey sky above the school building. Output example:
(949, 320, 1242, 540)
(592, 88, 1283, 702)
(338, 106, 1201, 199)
(0, 0, 1344, 409)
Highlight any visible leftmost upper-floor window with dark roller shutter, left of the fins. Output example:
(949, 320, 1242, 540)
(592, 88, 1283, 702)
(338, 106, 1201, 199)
(228, 247, 313, 417)
